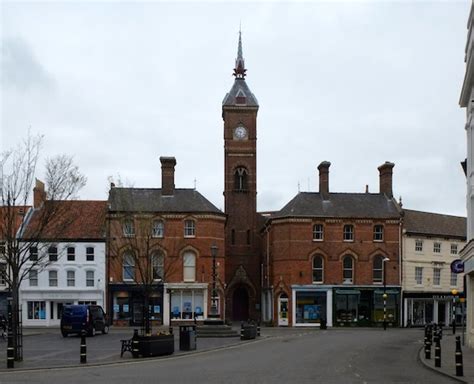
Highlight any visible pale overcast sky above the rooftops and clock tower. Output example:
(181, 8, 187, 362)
(0, 0, 471, 215)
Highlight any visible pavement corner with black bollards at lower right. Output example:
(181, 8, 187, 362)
(419, 328, 474, 384)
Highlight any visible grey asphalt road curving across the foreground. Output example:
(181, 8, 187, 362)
(0, 329, 453, 384)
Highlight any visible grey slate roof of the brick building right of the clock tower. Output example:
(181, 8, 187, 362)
(271, 192, 400, 219)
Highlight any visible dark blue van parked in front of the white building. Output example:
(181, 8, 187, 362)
(61, 305, 109, 337)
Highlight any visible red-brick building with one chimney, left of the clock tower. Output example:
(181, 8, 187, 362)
(107, 157, 225, 325)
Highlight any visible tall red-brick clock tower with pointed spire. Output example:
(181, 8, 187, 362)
(222, 32, 260, 320)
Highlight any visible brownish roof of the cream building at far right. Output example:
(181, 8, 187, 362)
(403, 209, 467, 239)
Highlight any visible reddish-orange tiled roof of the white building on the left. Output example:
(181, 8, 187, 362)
(23, 200, 107, 240)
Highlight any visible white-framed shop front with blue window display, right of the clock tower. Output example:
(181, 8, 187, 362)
(290, 286, 333, 327)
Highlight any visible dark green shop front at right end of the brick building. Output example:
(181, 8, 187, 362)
(334, 287, 400, 327)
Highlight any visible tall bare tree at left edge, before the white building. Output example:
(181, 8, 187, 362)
(0, 134, 86, 360)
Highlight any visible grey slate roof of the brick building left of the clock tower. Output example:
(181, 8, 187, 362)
(109, 187, 224, 215)
